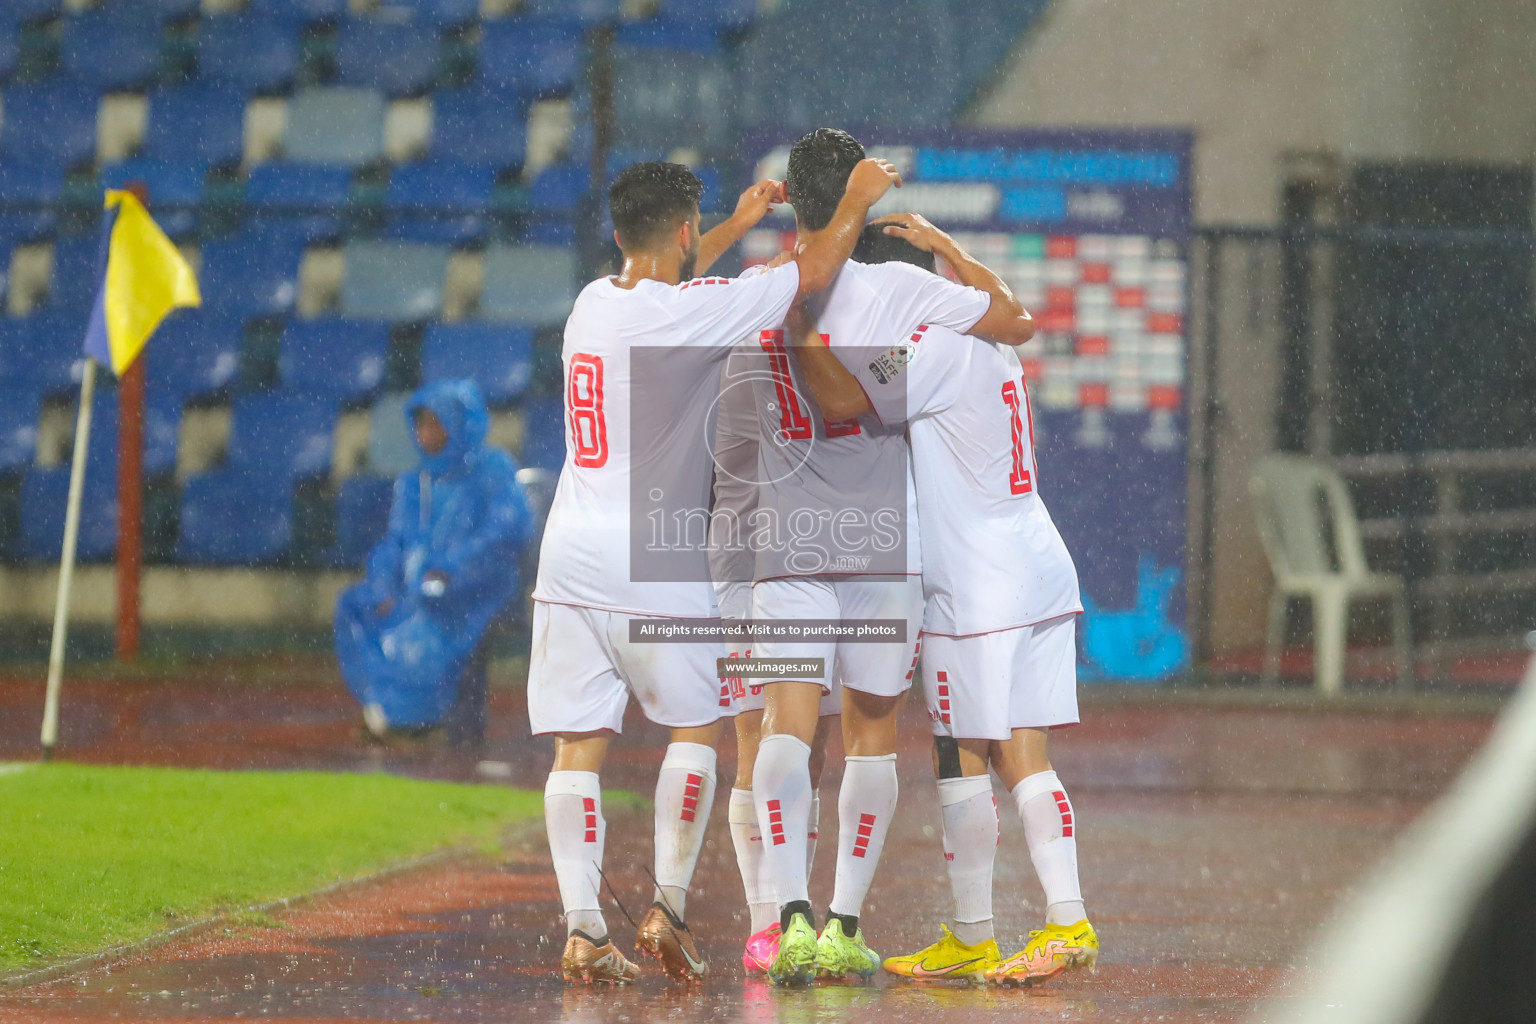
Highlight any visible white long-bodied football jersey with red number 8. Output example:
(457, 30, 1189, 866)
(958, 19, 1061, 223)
(533, 263, 800, 617)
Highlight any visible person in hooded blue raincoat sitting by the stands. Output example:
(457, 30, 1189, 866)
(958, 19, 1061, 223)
(336, 381, 531, 745)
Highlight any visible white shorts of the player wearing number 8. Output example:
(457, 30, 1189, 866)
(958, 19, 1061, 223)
(528, 600, 736, 735)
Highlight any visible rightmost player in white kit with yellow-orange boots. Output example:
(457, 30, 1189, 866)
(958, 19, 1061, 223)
(796, 222, 1098, 984)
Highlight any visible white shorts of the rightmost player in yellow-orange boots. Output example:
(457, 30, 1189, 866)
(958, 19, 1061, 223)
(923, 614, 1078, 740)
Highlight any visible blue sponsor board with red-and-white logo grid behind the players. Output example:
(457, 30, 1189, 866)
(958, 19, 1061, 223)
(742, 129, 1192, 683)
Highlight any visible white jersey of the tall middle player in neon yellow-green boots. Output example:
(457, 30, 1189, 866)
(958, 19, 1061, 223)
(754, 259, 992, 580)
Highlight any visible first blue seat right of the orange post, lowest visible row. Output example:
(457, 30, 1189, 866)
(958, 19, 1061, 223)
(175, 468, 293, 565)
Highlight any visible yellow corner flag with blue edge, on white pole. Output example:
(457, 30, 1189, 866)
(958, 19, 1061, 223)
(86, 190, 203, 376)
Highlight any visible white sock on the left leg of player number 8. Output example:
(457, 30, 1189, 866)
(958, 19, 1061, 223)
(544, 772, 608, 943)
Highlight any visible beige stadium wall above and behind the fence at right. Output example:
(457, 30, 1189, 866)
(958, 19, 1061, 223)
(968, 0, 1536, 654)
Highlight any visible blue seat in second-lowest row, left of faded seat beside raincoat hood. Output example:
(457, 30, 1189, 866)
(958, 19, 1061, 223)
(224, 395, 336, 481)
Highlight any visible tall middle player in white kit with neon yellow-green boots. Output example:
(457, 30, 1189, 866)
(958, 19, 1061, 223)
(740, 129, 1034, 984)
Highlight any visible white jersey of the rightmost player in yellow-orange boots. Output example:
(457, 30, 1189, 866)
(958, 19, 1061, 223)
(854, 325, 1083, 636)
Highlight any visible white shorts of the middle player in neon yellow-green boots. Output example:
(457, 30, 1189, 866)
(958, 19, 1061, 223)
(737, 576, 923, 715)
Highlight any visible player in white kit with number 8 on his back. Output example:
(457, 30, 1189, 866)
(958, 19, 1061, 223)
(528, 160, 900, 983)
